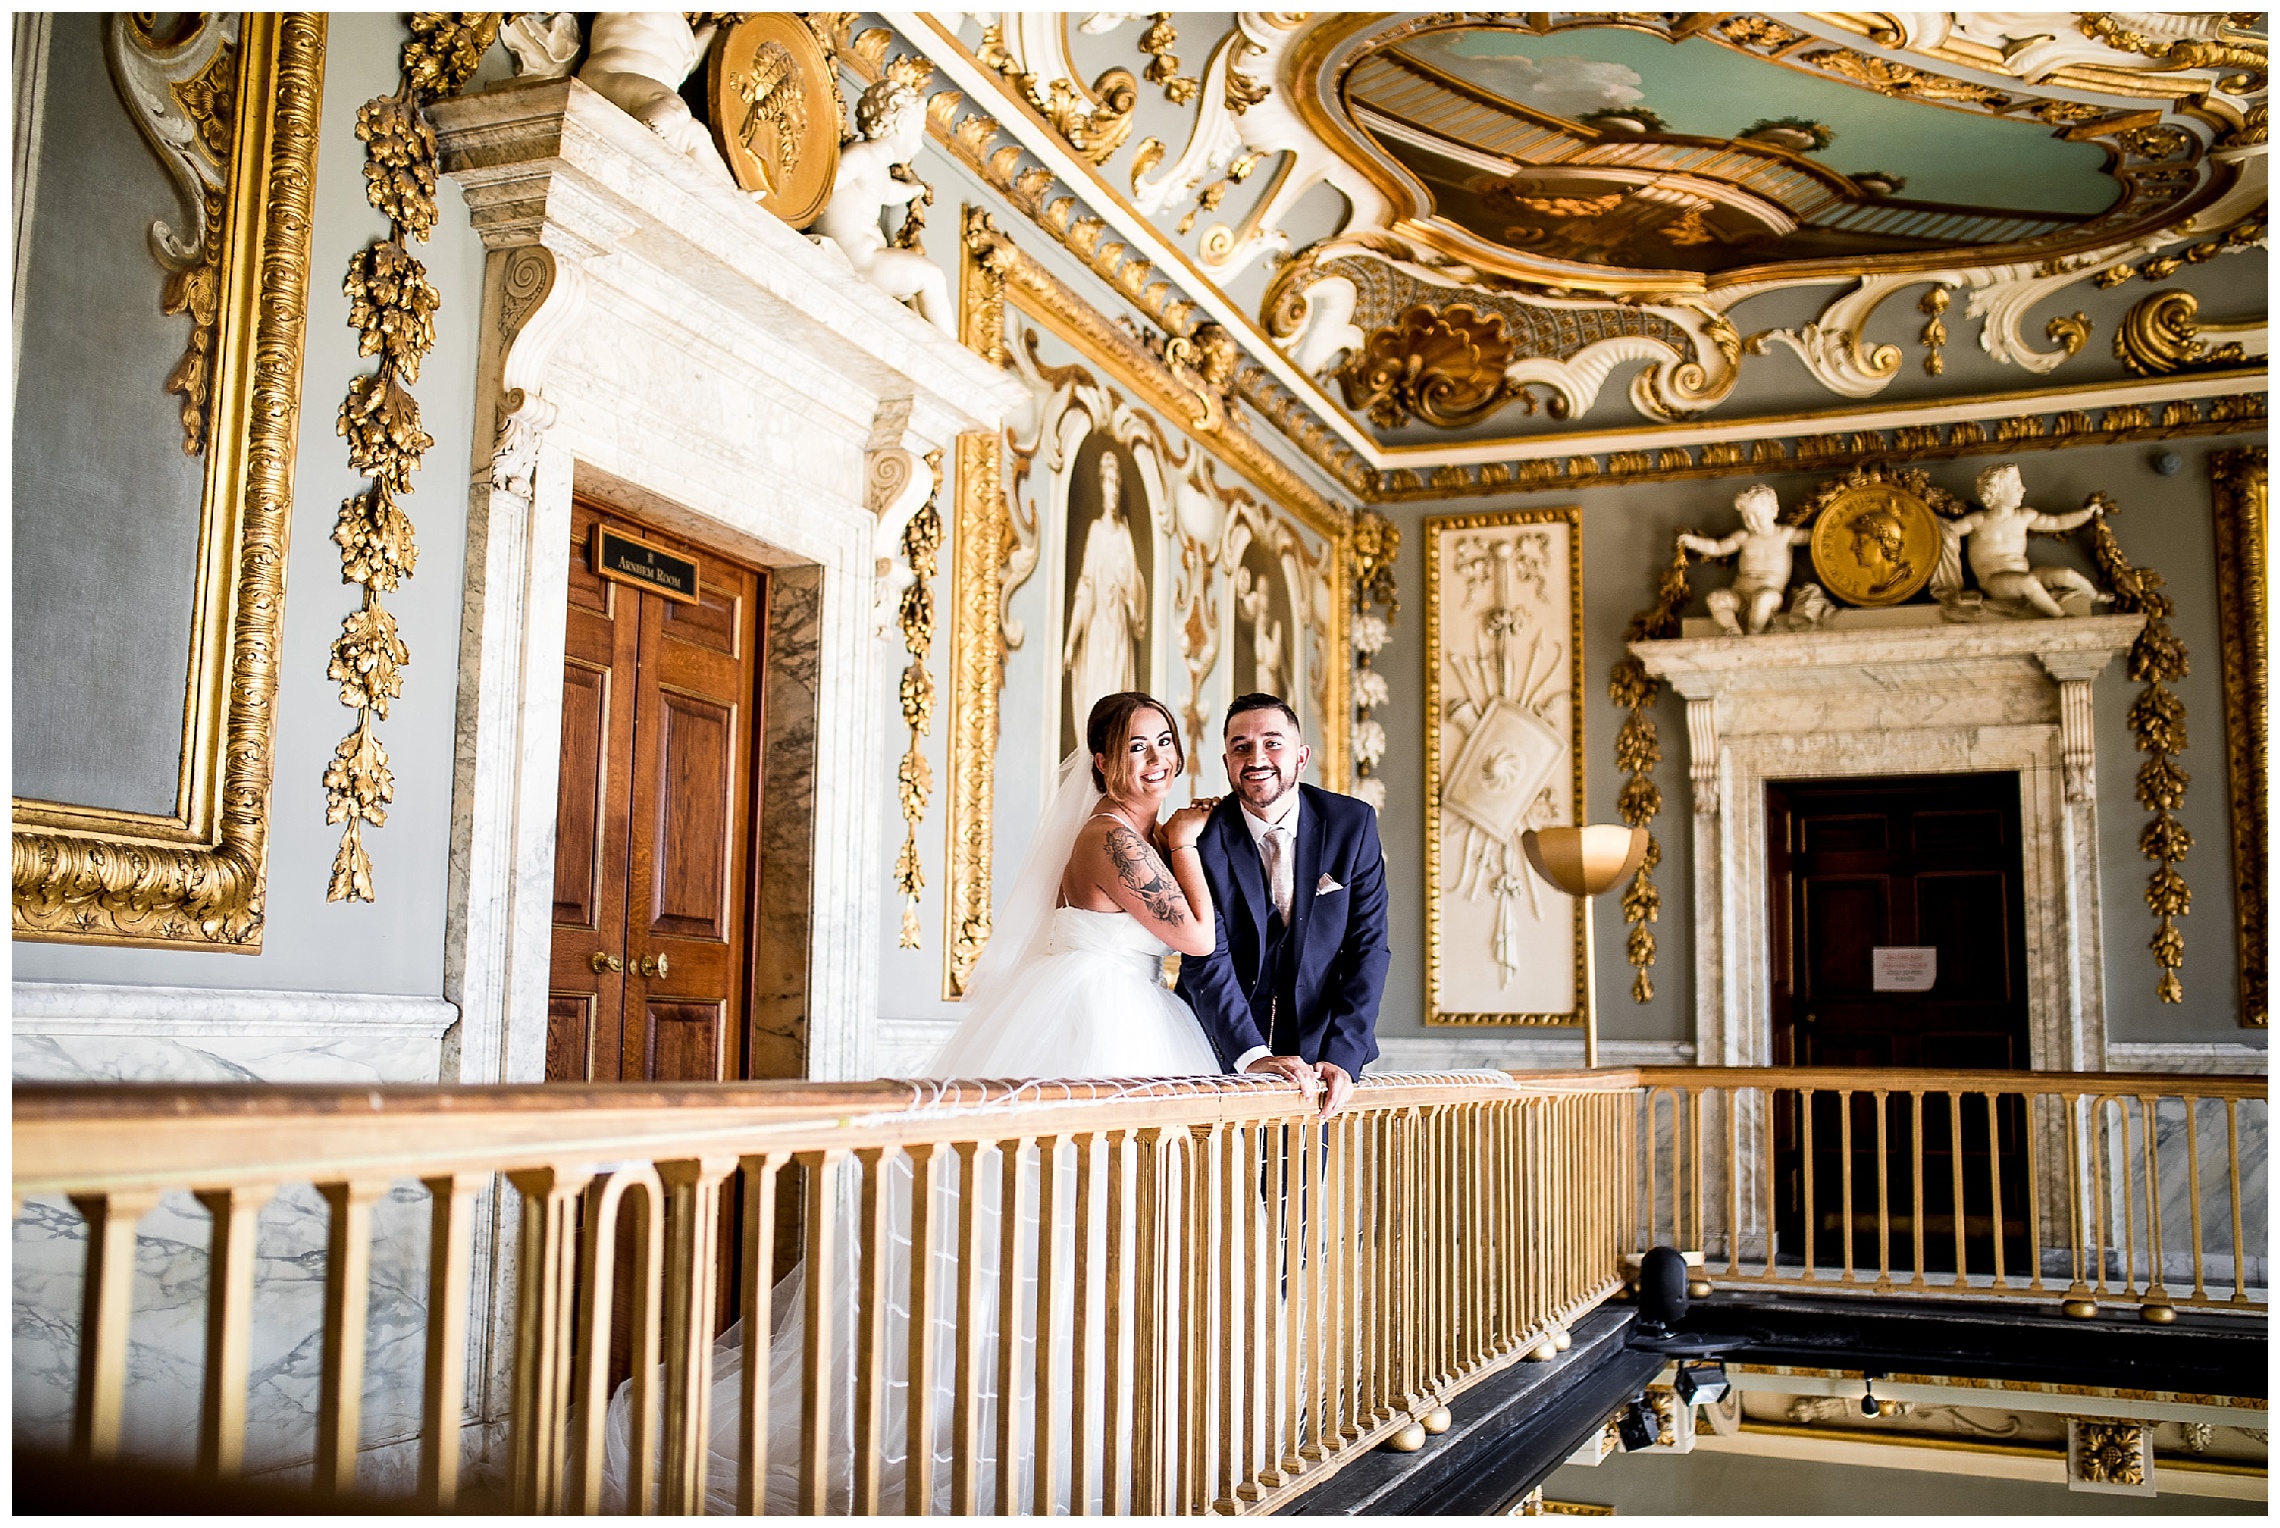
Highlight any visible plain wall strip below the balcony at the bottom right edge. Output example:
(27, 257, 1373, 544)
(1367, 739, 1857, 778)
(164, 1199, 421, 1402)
(1544, 1453, 2264, 1517)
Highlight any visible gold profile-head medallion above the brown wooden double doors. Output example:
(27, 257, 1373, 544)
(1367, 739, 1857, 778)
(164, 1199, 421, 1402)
(705, 11, 846, 228)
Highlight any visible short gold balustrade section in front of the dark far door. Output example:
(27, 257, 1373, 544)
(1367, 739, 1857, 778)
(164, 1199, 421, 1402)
(1632, 1067, 2269, 1320)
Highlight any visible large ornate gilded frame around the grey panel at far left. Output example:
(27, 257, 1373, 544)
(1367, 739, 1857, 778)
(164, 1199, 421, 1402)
(11, 11, 326, 953)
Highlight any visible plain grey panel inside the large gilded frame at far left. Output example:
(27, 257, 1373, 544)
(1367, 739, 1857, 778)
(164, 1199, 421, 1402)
(9, 11, 205, 816)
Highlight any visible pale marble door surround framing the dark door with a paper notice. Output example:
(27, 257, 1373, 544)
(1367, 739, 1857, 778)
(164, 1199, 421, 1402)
(1630, 616, 2143, 1072)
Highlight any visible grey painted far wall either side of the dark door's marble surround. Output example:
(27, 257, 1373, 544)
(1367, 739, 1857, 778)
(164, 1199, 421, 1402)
(1377, 436, 2262, 1042)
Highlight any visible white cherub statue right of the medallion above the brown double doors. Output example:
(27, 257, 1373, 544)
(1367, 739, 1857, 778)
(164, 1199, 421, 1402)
(819, 59, 958, 338)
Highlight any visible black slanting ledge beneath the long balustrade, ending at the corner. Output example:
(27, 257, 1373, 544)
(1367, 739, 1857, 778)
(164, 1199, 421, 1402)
(1277, 1305, 1664, 1517)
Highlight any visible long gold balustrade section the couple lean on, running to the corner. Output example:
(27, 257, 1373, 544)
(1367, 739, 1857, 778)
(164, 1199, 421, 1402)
(14, 1072, 1637, 1514)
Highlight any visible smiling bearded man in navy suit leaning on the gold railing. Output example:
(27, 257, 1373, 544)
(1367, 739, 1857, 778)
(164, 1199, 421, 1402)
(1179, 693, 1386, 1120)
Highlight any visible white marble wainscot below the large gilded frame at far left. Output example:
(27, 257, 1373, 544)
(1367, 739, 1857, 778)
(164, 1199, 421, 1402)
(9, 983, 458, 1489)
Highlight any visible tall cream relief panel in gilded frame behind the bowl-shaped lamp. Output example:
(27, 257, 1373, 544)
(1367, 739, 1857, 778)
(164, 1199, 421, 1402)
(1425, 506, 1591, 1026)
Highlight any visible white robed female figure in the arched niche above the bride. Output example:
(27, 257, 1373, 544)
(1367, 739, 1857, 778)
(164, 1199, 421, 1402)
(1060, 438, 1154, 748)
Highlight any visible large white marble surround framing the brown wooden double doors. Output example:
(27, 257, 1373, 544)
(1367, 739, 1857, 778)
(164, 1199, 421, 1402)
(433, 80, 1024, 1473)
